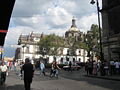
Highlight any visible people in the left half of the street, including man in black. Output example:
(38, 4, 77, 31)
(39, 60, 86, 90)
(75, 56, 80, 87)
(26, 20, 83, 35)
(0, 58, 60, 90)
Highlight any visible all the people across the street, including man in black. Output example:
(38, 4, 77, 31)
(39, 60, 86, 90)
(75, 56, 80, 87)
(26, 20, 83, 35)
(0, 58, 120, 90)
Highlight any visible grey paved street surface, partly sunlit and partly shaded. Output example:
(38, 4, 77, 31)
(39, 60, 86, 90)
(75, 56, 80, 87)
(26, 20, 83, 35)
(0, 71, 120, 90)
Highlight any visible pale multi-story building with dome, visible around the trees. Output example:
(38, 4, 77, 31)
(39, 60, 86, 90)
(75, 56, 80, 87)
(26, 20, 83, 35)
(15, 19, 88, 64)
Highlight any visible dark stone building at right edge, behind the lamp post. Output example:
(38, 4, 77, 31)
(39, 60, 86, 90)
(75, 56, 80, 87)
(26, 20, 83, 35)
(101, 0, 120, 61)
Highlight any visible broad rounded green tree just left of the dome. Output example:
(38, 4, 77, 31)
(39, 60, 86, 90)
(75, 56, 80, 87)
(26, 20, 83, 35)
(38, 34, 64, 56)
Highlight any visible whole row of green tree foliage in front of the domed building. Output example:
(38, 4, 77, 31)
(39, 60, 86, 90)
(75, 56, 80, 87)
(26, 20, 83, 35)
(38, 24, 99, 56)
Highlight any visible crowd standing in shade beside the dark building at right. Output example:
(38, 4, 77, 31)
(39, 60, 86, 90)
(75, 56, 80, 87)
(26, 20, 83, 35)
(85, 59, 120, 76)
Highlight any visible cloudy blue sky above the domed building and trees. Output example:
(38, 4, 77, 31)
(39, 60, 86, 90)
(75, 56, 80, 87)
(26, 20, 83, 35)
(4, 0, 101, 56)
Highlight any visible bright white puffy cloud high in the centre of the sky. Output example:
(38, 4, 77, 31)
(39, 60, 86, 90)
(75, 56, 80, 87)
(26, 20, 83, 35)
(46, 7, 72, 28)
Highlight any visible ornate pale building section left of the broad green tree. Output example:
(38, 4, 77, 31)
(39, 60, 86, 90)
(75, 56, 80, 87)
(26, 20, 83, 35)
(15, 32, 43, 61)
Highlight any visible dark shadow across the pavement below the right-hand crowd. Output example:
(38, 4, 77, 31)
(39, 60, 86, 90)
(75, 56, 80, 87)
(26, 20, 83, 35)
(61, 71, 120, 90)
